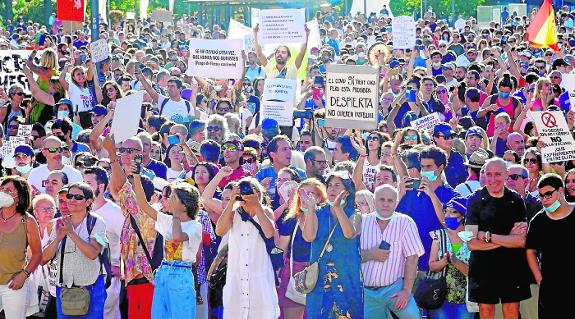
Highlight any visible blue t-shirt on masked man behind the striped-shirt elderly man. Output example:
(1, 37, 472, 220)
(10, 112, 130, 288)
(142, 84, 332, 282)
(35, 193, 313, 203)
(396, 184, 457, 271)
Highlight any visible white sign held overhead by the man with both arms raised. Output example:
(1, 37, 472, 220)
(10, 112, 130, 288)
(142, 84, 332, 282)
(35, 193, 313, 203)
(258, 9, 306, 45)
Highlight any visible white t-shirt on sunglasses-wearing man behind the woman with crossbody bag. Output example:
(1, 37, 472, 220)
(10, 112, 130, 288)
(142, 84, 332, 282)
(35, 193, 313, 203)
(94, 200, 126, 266)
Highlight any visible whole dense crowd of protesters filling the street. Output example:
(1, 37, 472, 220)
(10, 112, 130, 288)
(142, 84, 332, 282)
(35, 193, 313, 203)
(0, 6, 575, 319)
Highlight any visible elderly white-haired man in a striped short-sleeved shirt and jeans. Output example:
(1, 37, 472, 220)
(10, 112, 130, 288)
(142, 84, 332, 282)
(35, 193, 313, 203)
(360, 185, 424, 319)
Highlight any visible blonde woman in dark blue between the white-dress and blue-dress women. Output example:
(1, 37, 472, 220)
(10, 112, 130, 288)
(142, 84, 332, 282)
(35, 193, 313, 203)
(278, 178, 327, 319)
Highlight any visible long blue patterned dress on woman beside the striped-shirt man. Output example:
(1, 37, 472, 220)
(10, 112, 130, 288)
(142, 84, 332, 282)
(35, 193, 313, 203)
(306, 205, 363, 319)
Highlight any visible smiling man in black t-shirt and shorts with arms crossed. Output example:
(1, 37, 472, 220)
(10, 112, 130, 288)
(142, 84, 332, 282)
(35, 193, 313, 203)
(465, 158, 531, 318)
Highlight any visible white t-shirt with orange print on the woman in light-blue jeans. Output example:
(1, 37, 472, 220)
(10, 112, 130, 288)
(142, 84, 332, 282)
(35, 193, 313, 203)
(156, 212, 202, 263)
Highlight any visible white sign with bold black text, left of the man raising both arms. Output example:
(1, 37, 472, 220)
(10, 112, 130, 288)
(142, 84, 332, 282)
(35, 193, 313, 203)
(186, 39, 244, 79)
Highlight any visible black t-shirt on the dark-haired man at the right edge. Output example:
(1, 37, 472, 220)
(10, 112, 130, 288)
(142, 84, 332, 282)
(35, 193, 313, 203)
(525, 210, 575, 293)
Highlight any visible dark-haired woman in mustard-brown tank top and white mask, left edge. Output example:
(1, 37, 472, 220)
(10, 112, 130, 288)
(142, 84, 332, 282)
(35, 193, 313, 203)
(0, 176, 42, 319)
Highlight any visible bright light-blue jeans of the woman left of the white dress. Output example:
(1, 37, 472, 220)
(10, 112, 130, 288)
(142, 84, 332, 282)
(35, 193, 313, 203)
(152, 260, 196, 319)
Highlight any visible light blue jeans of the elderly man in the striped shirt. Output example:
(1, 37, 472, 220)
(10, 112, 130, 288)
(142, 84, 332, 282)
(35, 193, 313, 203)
(363, 278, 421, 319)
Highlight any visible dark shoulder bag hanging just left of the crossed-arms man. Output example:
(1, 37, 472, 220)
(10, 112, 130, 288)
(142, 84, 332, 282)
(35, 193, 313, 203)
(413, 229, 447, 309)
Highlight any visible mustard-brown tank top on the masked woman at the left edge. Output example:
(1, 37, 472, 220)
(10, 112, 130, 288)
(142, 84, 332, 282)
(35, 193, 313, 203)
(0, 217, 27, 285)
